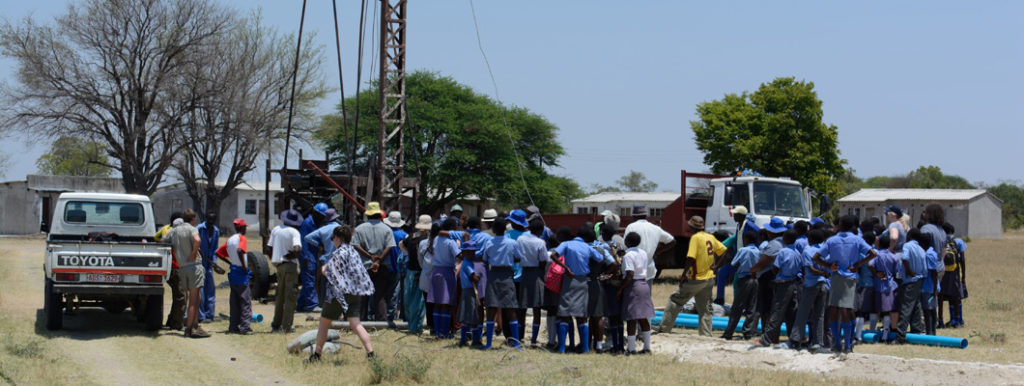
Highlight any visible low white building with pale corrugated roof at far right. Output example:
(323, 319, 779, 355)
(839, 189, 1002, 239)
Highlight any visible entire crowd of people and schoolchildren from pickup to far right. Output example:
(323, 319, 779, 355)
(158, 198, 967, 361)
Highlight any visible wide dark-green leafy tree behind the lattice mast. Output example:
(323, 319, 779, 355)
(316, 71, 582, 213)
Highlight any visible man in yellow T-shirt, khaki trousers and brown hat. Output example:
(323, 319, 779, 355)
(654, 216, 727, 337)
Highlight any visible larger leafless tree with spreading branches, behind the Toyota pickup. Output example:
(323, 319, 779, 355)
(0, 0, 230, 195)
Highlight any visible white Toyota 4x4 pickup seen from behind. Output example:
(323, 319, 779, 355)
(43, 192, 171, 330)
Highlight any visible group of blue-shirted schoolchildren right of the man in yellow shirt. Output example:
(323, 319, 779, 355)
(712, 204, 967, 353)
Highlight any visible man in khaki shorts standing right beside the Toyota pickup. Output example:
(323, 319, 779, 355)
(164, 209, 210, 338)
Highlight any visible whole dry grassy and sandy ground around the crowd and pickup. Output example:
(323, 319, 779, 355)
(6, 233, 1024, 385)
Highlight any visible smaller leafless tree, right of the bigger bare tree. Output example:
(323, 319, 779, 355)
(174, 15, 327, 218)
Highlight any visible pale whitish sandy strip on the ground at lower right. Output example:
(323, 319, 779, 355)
(651, 334, 1024, 385)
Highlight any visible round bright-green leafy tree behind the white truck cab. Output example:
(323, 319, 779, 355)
(690, 78, 846, 195)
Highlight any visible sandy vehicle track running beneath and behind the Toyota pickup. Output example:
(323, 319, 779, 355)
(0, 238, 297, 384)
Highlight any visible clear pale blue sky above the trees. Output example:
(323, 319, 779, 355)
(0, 0, 1024, 190)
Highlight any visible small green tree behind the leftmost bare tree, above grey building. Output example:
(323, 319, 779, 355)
(36, 136, 112, 177)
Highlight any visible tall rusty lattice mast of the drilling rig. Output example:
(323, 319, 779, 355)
(374, 0, 407, 210)
